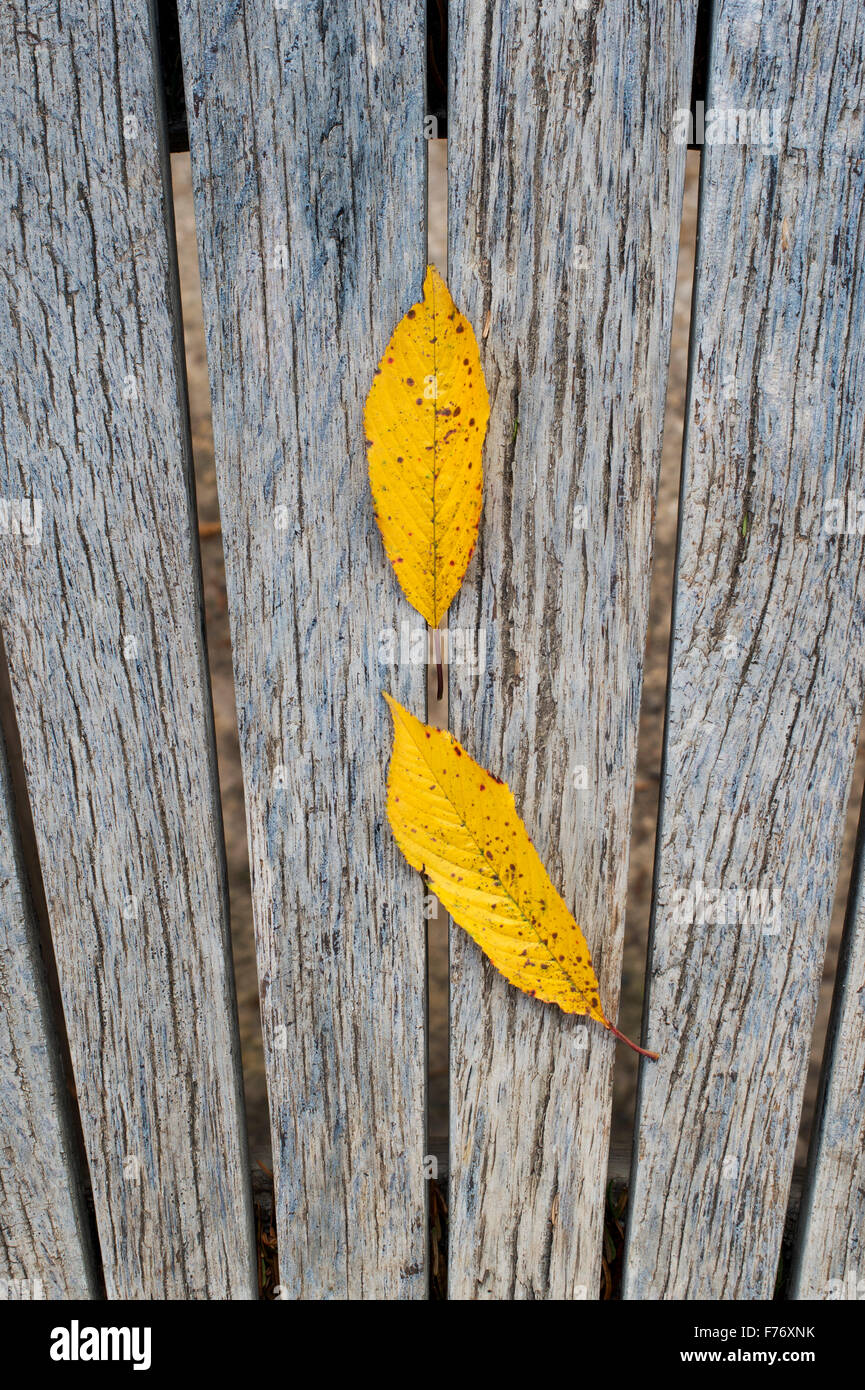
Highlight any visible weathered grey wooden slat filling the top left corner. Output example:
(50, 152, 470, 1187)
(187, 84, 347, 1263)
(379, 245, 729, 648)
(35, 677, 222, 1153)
(0, 0, 256, 1298)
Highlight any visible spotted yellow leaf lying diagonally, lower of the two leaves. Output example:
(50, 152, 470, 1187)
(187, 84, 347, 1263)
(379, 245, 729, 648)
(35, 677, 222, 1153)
(385, 695, 656, 1058)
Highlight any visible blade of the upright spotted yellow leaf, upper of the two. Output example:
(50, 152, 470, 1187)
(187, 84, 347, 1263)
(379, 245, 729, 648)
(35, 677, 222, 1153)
(364, 265, 490, 627)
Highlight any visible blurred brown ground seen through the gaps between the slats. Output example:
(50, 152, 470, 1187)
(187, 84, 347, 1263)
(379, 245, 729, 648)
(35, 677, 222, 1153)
(171, 140, 865, 1166)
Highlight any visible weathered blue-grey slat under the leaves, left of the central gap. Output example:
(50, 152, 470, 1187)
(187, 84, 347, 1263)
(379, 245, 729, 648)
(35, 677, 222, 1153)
(179, 0, 427, 1298)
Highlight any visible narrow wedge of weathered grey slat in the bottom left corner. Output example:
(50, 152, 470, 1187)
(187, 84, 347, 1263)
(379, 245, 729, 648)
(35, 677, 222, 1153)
(0, 737, 97, 1298)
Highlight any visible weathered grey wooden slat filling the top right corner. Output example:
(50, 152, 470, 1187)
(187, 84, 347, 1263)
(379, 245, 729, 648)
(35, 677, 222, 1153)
(624, 0, 865, 1298)
